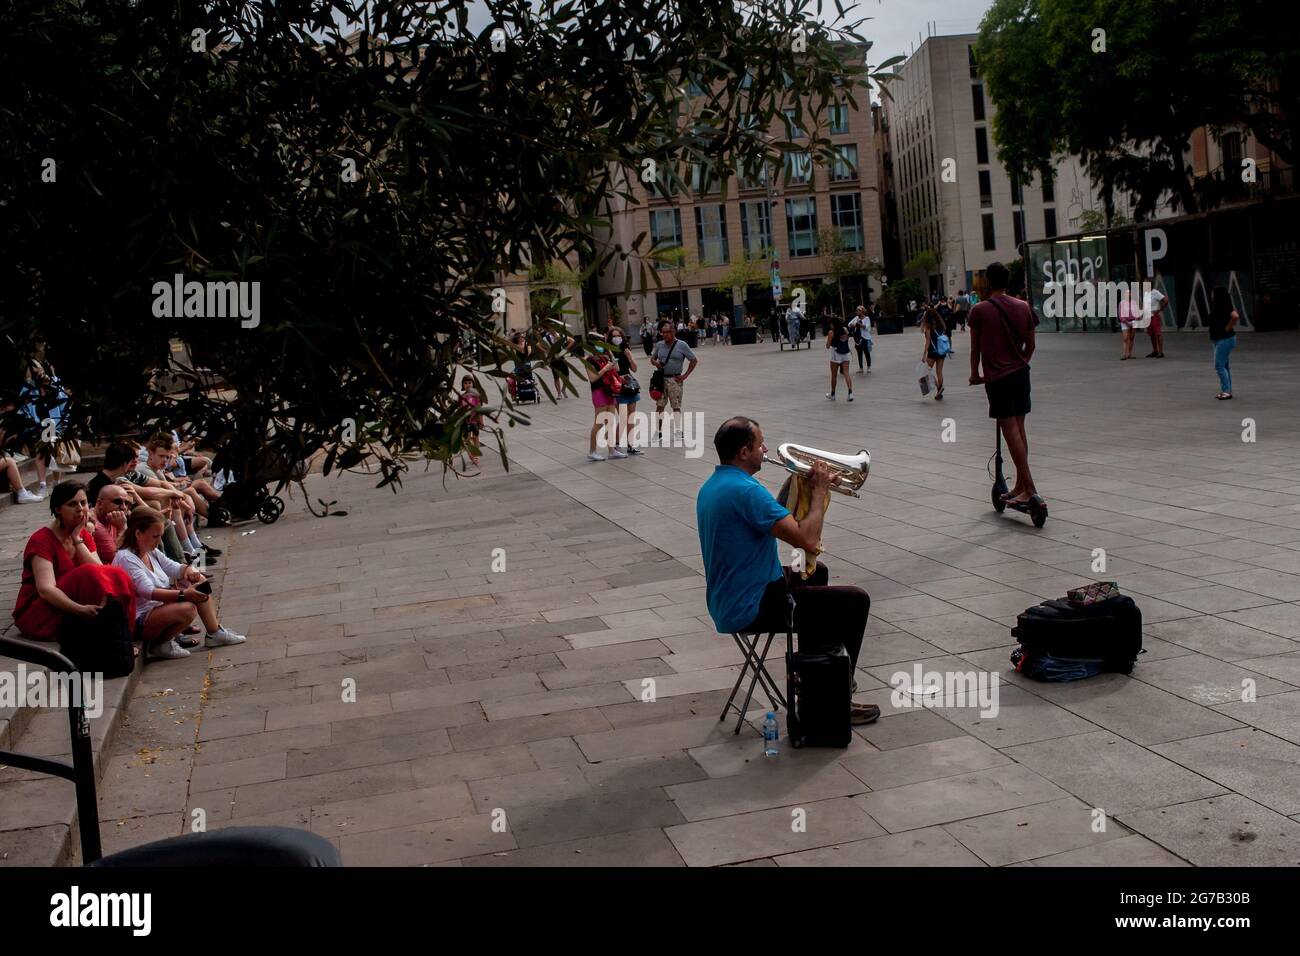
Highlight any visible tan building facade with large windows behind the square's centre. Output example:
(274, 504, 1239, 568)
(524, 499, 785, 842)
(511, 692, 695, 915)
(595, 63, 884, 328)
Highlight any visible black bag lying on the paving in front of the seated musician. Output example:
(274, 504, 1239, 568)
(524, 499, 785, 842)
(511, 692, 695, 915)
(1011, 594, 1141, 674)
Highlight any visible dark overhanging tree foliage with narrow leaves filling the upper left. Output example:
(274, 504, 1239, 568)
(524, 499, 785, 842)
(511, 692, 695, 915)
(0, 0, 894, 484)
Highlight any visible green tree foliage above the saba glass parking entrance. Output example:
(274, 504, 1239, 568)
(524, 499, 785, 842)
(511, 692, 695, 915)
(976, 0, 1300, 217)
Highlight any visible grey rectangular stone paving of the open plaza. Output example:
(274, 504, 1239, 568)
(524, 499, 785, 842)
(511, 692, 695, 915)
(10, 327, 1300, 866)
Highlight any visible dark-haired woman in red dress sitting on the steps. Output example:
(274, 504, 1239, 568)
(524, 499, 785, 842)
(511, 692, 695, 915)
(13, 481, 135, 641)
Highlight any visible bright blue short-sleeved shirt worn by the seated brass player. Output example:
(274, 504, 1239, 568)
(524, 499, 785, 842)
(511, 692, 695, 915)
(696, 464, 789, 633)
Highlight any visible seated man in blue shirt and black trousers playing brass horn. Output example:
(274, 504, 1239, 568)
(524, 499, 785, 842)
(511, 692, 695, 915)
(696, 416, 880, 724)
